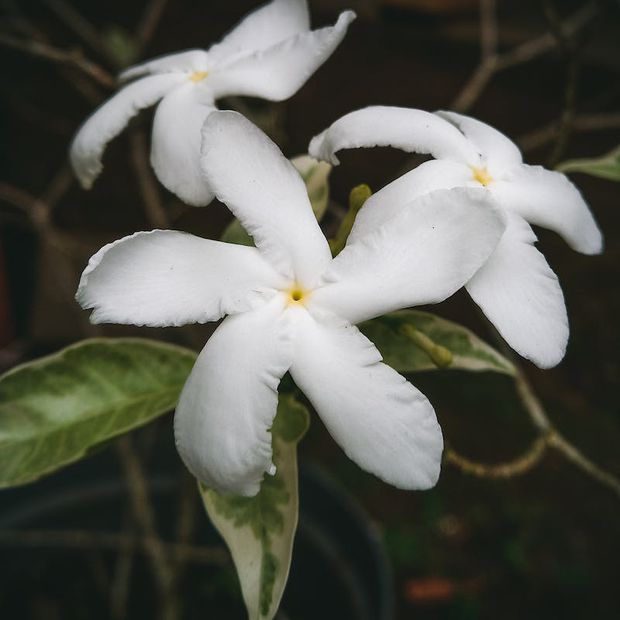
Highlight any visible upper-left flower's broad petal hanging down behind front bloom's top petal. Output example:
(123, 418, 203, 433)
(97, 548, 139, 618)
(151, 81, 216, 207)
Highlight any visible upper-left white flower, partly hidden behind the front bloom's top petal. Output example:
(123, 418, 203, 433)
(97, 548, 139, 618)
(70, 0, 355, 206)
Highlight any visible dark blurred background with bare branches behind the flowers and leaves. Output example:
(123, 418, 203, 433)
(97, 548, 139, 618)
(0, 0, 620, 620)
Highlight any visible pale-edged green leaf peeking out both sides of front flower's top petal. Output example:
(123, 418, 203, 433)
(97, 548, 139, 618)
(220, 155, 332, 245)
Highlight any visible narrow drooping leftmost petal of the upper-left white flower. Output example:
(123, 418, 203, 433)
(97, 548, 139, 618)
(69, 73, 184, 189)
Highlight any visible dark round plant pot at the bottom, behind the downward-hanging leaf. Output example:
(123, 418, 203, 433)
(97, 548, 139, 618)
(0, 426, 394, 620)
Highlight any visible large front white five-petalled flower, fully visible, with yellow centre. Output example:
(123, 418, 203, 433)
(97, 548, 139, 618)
(77, 112, 504, 495)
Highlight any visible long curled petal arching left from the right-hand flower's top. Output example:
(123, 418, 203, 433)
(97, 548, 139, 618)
(308, 106, 479, 165)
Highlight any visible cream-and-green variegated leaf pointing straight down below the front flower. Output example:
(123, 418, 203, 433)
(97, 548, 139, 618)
(200, 394, 309, 620)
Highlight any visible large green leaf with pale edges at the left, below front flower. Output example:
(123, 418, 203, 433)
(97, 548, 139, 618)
(0, 338, 196, 487)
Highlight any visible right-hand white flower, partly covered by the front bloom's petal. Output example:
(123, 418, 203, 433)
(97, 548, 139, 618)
(309, 106, 603, 368)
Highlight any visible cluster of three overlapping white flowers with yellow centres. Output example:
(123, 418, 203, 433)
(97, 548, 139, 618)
(71, 0, 602, 496)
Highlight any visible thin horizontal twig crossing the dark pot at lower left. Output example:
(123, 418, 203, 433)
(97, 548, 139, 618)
(0, 529, 230, 566)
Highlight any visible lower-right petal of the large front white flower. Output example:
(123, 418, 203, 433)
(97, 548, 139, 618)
(290, 315, 443, 489)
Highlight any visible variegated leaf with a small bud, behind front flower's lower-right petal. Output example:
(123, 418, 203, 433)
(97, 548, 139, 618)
(360, 310, 515, 375)
